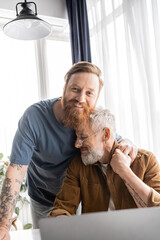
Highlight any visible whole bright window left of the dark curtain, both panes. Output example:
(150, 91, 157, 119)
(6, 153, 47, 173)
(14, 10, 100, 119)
(0, 16, 72, 156)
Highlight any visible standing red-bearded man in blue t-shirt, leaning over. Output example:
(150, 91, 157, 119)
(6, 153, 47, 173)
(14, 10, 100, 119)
(0, 62, 137, 240)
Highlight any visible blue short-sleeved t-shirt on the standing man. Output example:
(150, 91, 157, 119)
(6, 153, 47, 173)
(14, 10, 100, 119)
(10, 98, 78, 206)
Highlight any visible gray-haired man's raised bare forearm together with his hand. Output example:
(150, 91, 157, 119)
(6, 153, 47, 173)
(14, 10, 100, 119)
(110, 149, 150, 208)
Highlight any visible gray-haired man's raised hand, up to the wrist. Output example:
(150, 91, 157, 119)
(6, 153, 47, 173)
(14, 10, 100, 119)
(110, 149, 132, 178)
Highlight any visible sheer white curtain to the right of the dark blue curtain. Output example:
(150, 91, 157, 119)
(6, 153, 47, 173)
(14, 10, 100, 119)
(87, 0, 160, 159)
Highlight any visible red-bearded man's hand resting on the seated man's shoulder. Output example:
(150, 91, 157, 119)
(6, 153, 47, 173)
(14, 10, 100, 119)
(117, 139, 138, 162)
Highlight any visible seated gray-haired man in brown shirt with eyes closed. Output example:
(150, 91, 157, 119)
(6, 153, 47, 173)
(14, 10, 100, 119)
(49, 109, 160, 216)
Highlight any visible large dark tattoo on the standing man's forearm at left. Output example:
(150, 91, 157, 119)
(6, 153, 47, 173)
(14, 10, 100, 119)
(0, 178, 18, 229)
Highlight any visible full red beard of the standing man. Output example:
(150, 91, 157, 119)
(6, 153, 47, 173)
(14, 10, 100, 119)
(62, 99, 93, 130)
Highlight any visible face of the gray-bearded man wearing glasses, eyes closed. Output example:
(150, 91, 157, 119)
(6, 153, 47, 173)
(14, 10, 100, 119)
(75, 127, 105, 165)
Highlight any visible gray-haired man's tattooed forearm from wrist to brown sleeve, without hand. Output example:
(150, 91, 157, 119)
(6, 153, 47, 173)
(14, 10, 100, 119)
(121, 169, 150, 208)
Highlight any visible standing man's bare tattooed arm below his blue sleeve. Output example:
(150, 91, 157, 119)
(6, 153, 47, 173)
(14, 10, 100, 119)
(0, 163, 28, 240)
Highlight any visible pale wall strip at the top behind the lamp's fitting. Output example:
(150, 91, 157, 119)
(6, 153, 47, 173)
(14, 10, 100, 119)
(0, 0, 67, 18)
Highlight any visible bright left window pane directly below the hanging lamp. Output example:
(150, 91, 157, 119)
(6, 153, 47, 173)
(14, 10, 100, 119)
(0, 31, 38, 155)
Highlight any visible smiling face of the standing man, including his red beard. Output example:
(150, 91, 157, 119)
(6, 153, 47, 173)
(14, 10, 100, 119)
(62, 72, 99, 129)
